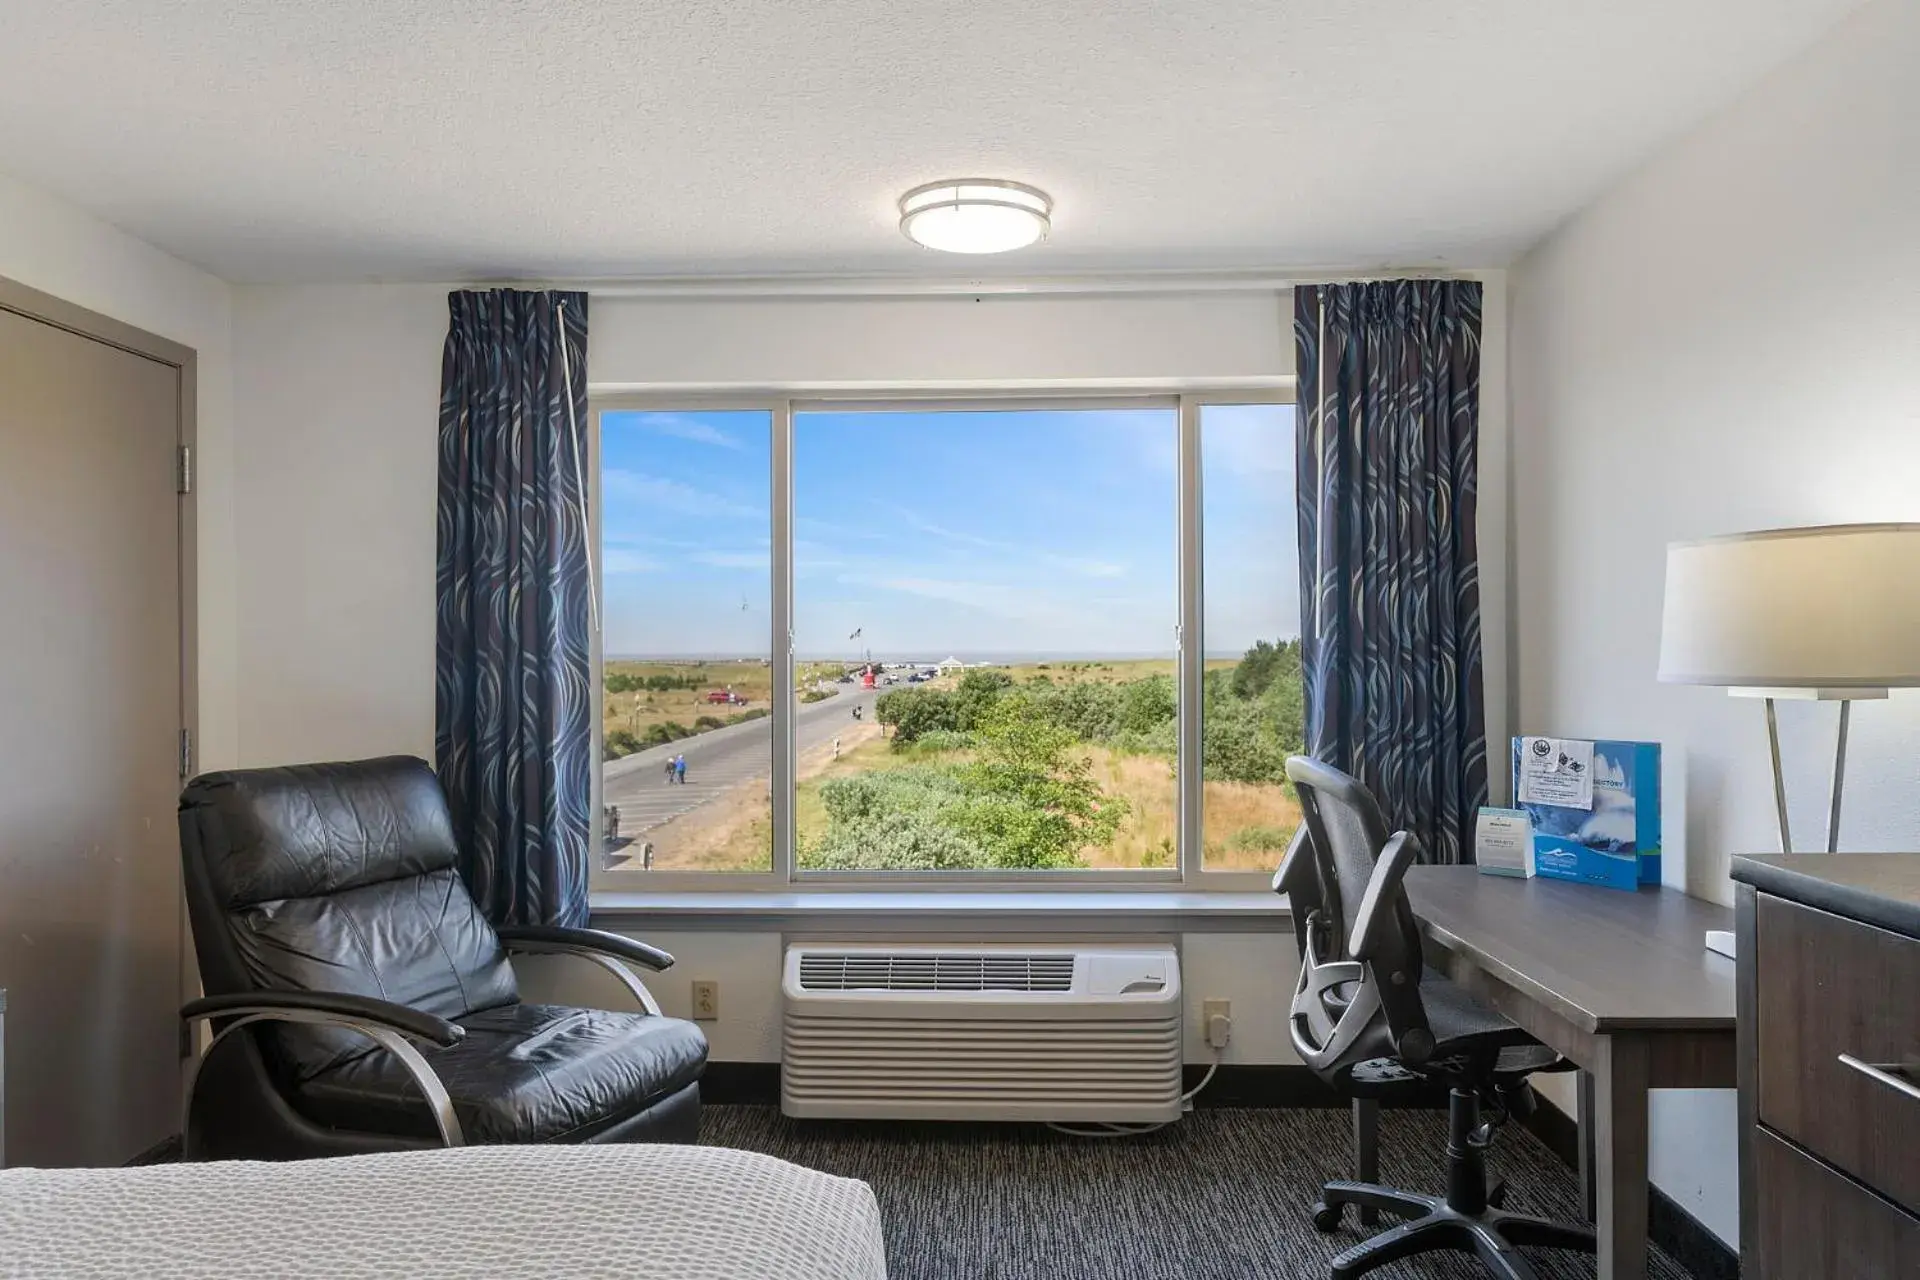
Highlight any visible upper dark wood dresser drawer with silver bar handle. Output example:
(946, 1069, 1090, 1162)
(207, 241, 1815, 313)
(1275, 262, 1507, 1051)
(1755, 894, 1920, 1211)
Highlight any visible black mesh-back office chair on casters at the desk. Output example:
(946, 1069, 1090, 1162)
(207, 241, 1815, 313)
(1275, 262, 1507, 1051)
(1273, 756, 1594, 1280)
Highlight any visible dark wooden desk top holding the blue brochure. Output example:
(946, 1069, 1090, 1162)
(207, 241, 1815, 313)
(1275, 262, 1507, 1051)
(1407, 867, 1734, 1032)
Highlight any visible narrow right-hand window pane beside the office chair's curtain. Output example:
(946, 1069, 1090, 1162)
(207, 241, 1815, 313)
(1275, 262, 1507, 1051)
(1200, 405, 1306, 871)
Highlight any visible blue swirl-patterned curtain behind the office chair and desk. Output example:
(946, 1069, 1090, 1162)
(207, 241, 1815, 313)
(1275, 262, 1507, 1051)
(1294, 280, 1486, 862)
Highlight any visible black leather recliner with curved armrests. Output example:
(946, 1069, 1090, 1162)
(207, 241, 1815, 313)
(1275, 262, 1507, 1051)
(180, 756, 707, 1159)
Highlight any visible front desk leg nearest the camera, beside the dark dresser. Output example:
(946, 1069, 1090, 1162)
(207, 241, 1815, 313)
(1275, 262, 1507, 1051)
(1594, 1034, 1651, 1280)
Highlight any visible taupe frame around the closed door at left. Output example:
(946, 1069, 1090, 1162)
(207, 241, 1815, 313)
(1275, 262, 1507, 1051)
(0, 276, 202, 1059)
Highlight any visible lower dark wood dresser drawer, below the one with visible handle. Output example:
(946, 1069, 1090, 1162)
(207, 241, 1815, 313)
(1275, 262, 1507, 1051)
(1753, 1128, 1920, 1280)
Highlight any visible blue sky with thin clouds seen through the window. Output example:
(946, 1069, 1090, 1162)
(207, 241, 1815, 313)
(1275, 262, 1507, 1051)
(601, 405, 1300, 658)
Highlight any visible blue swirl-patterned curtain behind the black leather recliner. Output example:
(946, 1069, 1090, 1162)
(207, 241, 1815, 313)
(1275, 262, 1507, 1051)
(434, 290, 593, 925)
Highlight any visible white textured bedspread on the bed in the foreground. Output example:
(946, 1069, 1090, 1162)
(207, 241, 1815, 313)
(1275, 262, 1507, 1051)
(0, 1144, 887, 1280)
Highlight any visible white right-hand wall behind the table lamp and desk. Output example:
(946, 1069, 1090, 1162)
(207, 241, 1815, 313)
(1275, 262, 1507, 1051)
(1511, 0, 1920, 1242)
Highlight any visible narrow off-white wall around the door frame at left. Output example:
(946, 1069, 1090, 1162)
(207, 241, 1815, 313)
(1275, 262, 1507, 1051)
(0, 175, 238, 768)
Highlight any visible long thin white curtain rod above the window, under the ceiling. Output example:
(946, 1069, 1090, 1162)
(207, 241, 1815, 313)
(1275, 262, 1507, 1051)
(472, 267, 1486, 299)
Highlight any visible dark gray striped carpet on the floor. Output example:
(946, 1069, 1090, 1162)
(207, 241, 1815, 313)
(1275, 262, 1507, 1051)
(701, 1107, 1686, 1280)
